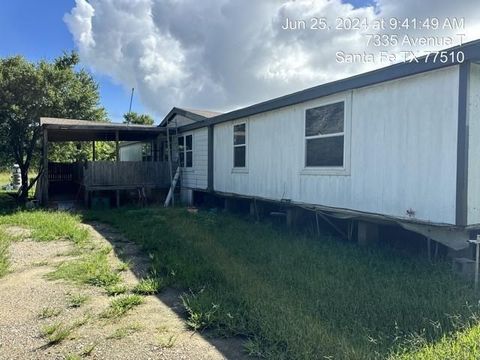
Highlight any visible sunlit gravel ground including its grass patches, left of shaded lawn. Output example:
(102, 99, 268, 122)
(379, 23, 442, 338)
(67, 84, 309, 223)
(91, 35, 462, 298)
(0, 211, 244, 360)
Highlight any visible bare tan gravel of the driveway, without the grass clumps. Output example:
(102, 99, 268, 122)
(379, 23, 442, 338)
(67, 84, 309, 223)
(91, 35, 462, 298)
(0, 224, 245, 360)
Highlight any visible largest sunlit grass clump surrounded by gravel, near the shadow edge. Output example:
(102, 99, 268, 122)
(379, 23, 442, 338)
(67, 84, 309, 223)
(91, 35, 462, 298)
(47, 249, 121, 288)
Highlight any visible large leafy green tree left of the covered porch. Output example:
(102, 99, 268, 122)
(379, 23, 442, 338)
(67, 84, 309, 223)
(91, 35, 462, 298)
(0, 52, 106, 201)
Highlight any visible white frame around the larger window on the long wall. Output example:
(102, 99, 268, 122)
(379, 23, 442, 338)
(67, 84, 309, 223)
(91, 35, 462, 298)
(300, 92, 352, 176)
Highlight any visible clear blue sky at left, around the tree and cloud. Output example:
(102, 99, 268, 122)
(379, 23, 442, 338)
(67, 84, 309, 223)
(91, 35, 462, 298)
(0, 0, 144, 121)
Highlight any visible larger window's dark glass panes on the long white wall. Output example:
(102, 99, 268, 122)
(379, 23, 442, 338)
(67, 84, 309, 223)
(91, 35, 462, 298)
(305, 102, 345, 167)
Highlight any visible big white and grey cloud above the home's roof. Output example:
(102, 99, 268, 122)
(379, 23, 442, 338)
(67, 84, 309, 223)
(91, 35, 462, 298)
(64, 0, 480, 116)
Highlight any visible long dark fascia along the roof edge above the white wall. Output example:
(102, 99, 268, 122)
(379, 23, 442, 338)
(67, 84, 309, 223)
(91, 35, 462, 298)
(179, 40, 480, 131)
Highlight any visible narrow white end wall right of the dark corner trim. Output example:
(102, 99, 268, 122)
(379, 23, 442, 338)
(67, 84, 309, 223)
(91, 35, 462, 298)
(467, 64, 480, 225)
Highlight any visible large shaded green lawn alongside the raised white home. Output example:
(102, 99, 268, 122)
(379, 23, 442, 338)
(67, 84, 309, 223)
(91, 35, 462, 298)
(88, 208, 480, 359)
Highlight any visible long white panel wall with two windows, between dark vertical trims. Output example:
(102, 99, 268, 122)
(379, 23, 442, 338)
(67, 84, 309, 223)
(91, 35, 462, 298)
(214, 66, 459, 224)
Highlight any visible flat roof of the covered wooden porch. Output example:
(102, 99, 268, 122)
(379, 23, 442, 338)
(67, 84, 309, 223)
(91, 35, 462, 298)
(40, 118, 166, 142)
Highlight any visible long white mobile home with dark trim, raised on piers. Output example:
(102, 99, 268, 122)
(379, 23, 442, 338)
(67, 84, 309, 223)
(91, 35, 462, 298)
(163, 41, 480, 249)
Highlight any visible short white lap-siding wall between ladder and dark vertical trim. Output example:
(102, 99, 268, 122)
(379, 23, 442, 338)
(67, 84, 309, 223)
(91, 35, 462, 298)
(181, 128, 208, 190)
